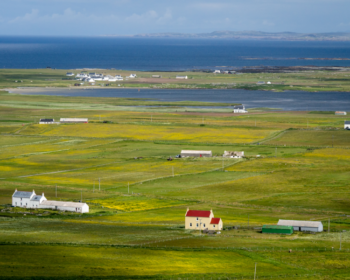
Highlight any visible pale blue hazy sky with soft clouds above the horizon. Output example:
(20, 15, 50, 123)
(0, 0, 350, 36)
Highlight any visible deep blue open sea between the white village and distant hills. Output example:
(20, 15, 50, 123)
(0, 36, 350, 71)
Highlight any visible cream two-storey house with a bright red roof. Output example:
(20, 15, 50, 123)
(185, 208, 223, 230)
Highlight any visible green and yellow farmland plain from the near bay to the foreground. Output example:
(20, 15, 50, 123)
(0, 91, 350, 280)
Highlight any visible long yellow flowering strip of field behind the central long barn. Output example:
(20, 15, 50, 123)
(22, 124, 277, 143)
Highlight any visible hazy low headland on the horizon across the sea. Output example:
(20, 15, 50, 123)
(105, 31, 350, 41)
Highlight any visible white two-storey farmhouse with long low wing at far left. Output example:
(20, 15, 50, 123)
(12, 189, 89, 213)
